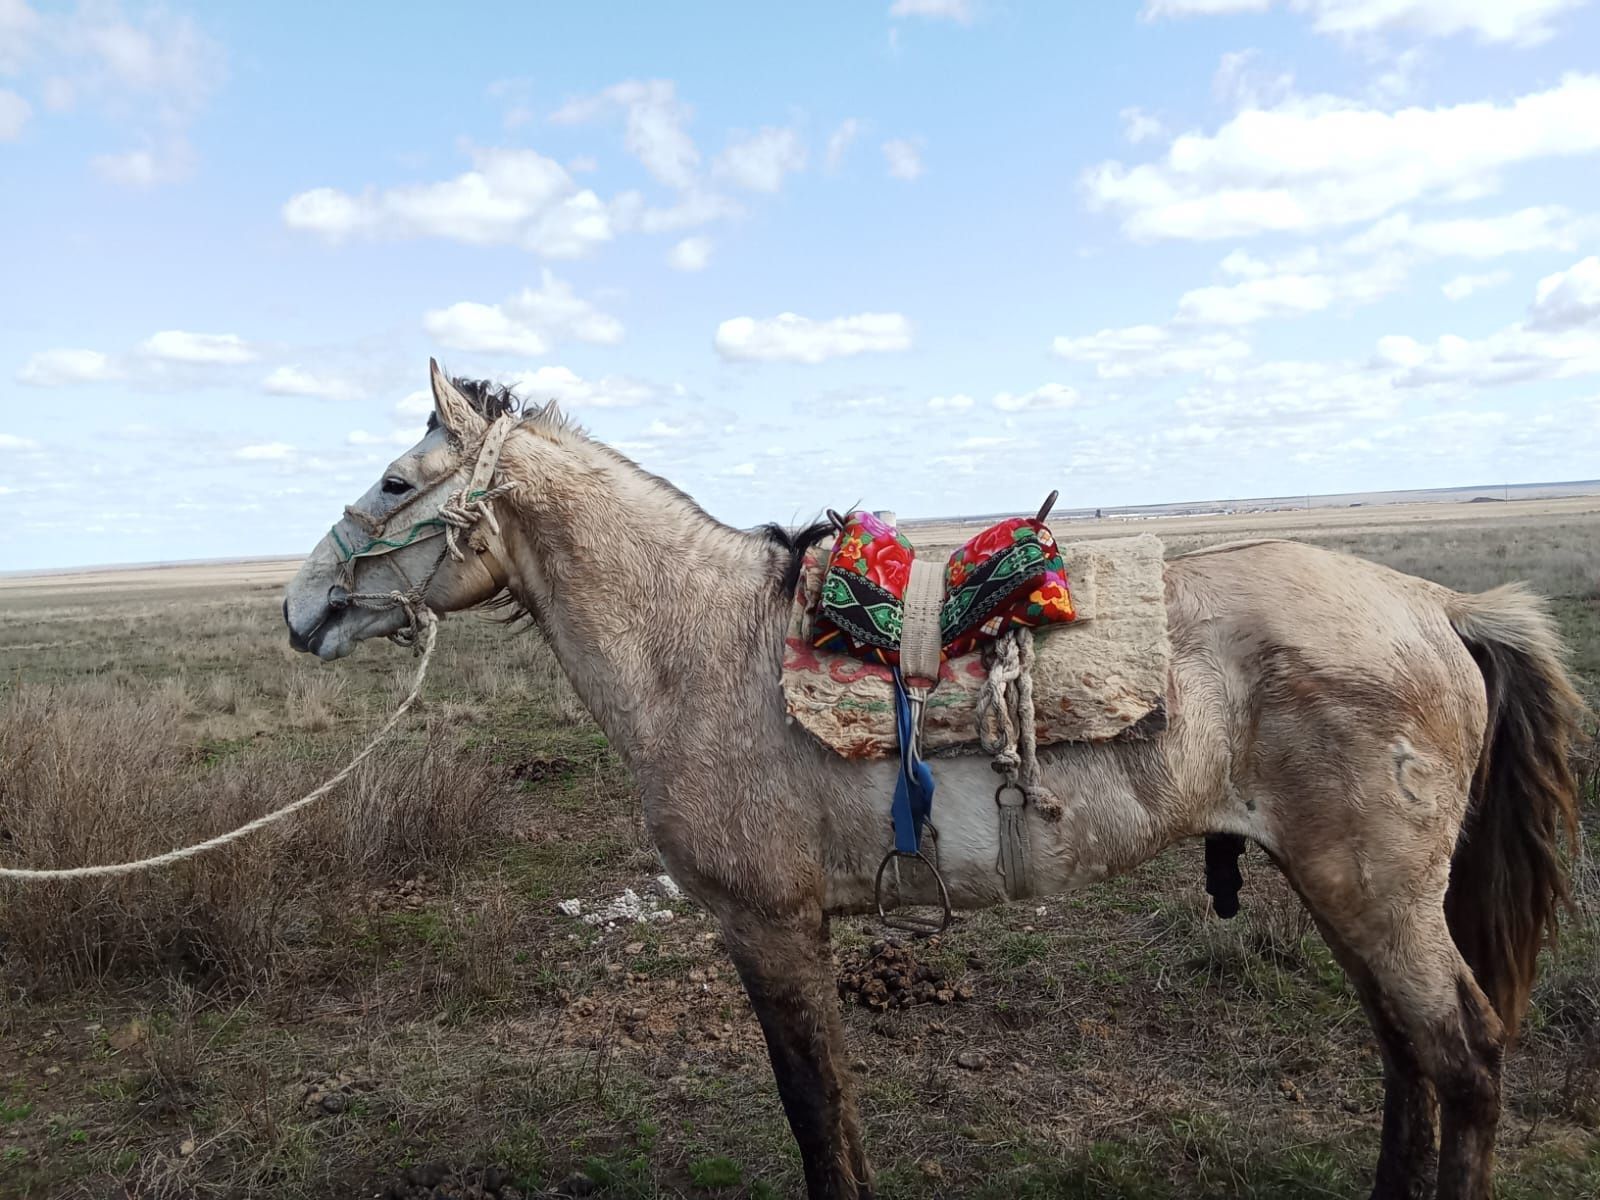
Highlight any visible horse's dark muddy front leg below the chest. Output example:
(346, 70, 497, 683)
(722, 904, 872, 1200)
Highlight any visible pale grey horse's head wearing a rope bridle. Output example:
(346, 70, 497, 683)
(283, 363, 517, 659)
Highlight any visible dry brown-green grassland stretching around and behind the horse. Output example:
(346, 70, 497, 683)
(0, 504, 1600, 1200)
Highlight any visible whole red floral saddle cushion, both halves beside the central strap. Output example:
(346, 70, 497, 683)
(813, 512, 1077, 666)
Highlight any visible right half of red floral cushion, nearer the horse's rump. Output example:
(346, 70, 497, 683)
(939, 517, 1077, 658)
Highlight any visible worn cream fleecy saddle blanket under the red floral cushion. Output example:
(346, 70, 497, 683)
(782, 534, 1171, 758)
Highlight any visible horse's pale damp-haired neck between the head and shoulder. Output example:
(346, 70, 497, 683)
(507, 443, 781, 758)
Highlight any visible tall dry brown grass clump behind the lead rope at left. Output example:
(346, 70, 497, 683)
(0, 683, 506, 990)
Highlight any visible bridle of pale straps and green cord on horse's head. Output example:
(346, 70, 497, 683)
(328, 413, 517, 651)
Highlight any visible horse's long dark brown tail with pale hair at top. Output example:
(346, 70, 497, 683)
(1445, 584, 1584, 1037)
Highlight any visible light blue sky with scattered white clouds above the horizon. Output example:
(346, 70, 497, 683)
(0, 0, 1600, 570)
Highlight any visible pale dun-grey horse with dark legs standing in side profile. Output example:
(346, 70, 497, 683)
(283, 363, 1582, 1200)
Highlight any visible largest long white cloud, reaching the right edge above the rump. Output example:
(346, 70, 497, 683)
(1083, 75, 1600, 238)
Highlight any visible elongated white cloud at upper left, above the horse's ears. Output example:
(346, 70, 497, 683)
(283, 149, 614, 258)
